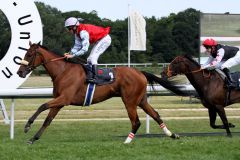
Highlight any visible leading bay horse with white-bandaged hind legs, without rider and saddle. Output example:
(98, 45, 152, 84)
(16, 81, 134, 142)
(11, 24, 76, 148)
(17, 43, 185, 144)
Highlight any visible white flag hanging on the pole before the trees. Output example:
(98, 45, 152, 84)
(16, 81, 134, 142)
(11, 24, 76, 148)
(129, 10, 146, 51)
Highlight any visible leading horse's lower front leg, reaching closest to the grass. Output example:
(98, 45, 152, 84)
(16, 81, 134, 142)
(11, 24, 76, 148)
(28, 106, 63, 144)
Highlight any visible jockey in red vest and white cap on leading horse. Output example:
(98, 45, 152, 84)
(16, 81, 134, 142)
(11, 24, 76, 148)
(64, 17, 111, 83)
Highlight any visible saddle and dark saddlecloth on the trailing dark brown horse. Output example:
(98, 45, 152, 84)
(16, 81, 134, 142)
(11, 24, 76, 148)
(216, 69, 240, 90)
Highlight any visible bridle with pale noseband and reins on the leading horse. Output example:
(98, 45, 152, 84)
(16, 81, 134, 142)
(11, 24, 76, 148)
(21, 48, 65, 71)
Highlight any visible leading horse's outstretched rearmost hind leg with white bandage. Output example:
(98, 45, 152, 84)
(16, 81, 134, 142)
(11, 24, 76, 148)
(139, 96, 179, 139)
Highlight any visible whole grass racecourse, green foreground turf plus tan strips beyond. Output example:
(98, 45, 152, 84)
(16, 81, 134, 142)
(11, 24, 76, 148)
(0, 77, 240, 160)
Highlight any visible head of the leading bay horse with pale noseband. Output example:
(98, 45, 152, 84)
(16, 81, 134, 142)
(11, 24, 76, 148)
(17, 42, 42, 78)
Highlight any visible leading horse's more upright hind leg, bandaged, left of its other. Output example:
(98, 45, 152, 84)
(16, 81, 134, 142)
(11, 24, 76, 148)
(124, 104, 141, 144)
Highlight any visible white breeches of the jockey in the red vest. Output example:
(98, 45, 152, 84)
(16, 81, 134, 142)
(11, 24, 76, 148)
(87, 35, 112, 64)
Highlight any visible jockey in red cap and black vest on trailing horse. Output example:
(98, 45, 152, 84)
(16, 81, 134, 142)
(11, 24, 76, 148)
(201, 38, 240, 87)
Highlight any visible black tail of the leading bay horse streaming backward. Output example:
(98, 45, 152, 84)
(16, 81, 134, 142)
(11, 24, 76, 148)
(141, 71, 189, 96)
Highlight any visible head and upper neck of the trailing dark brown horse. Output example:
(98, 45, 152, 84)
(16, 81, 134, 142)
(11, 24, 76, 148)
(167, 56, 200, 77)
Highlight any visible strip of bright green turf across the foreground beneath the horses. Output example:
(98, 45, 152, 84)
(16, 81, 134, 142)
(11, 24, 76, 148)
(0, 119, 240, 160)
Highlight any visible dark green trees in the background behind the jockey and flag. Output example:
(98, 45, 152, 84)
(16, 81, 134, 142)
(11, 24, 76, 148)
(0, 2, 200, 63)
